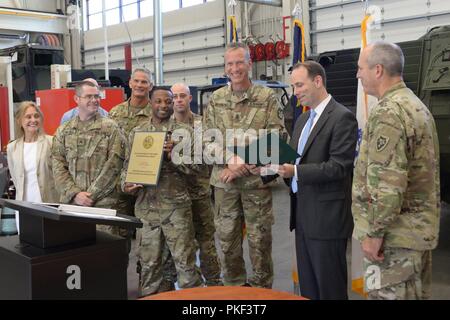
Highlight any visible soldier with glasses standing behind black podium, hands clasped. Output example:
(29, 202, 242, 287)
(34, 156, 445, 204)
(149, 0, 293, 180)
(52, 82, 125, 209)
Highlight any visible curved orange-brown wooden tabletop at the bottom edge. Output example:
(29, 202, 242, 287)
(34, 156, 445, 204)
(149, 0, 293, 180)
(140, 286, 307, 300)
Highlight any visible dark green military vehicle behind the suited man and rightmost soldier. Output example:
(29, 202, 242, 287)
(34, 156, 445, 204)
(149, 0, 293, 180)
(314, 26, 450, 203)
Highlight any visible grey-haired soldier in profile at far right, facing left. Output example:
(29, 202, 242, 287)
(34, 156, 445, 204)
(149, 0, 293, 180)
(352, 42, 440, 299)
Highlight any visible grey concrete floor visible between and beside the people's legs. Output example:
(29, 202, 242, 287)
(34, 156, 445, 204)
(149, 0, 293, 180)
(128, 182, 450, 300)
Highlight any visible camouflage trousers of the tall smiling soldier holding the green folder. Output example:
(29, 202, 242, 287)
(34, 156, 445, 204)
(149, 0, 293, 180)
(214, 188, 273, 288)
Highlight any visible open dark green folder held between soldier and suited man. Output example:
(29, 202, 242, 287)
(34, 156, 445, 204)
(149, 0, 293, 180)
(230, 132, 300, 166)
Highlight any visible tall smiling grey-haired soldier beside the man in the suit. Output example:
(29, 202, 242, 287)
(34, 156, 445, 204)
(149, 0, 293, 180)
(204, 43, 285, 288)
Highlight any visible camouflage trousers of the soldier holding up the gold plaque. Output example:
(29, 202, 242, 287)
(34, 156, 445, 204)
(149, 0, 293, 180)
(137, 207, 202, 296)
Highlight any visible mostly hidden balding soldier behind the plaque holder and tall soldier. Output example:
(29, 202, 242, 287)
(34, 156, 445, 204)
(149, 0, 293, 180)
(166, 83, 222, 286)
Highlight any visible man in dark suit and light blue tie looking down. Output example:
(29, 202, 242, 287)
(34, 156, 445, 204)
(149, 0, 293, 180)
(278, 61, 358, 299)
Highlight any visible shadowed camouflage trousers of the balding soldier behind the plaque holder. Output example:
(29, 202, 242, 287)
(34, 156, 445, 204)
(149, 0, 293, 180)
(162, 196, 222, 287)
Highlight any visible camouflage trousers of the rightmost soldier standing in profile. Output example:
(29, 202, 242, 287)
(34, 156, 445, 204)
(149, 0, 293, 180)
(364, 248, 431, 300)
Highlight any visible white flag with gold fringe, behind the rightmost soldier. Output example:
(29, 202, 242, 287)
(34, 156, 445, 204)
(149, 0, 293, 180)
(351, 14, 377, 296)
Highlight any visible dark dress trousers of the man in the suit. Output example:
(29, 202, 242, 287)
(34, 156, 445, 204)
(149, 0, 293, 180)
(295, 224, 348, 300)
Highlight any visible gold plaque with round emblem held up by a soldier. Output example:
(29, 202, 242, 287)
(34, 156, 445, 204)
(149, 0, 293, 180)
(125, 131, 167, 186)
